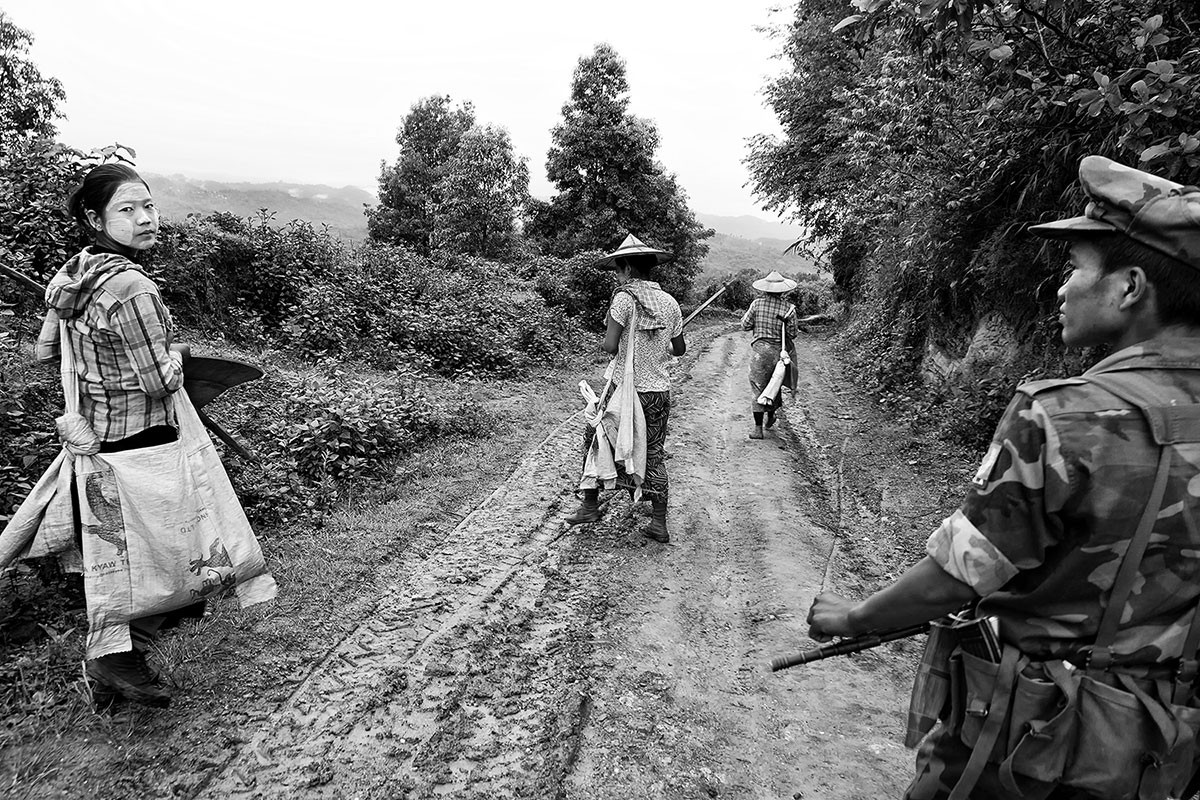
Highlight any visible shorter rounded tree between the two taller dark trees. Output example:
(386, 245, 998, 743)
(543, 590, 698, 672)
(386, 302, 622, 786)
(433, 126, 529, 260)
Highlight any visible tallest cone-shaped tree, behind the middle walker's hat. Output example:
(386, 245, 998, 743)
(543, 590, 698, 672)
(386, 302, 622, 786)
(527, 43, 713, 294)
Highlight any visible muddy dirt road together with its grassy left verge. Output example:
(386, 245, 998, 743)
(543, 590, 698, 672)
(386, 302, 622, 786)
(9, 318, 974, 800)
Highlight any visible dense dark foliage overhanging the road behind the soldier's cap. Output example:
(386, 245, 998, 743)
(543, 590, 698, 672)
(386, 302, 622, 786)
(748, 0, 1200, 441)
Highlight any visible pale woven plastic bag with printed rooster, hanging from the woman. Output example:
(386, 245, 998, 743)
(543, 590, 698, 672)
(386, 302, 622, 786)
(74, 376, 276, 658)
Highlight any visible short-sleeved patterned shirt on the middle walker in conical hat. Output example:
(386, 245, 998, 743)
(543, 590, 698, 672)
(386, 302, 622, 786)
(608, 281, 683, 392)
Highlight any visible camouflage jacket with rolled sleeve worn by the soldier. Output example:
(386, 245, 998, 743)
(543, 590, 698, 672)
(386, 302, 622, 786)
(926, 338, 1200, 673)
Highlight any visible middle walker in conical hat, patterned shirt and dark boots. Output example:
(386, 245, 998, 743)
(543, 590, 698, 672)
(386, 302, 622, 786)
(566, 234, 686, 542)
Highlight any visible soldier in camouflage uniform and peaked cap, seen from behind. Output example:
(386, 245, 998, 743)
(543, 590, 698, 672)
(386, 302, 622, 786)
(809, 156, 1200, 800)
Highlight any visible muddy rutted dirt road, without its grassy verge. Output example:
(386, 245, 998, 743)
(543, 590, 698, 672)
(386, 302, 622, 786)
(174, 332, 964, 800)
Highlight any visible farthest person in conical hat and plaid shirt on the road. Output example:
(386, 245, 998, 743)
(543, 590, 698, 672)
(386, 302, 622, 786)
(742, 271, 799, 439)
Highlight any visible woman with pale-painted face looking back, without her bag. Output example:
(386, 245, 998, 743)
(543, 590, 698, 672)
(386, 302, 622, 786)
(38, 164, 192, 705)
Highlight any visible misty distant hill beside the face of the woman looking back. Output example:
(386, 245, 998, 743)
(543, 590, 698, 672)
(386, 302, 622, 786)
(144, 174, 376, 241)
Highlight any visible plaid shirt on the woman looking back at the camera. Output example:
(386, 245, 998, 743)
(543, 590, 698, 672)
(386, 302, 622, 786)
(44, 253, 184, 441)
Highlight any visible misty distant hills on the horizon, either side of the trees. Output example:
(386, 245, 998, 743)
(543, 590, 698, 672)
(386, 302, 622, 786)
(144, 173, 815, 275)
